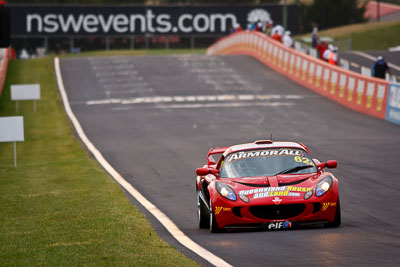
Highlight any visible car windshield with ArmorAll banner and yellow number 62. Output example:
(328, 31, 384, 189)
(219, 148, 317, 178)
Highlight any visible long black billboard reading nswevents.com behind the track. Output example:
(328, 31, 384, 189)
(10, 5, 299, 36)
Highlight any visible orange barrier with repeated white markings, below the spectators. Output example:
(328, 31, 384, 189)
(207, 32, 388, 119)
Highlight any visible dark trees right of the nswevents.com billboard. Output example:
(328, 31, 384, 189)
(302, 0, 365, 31)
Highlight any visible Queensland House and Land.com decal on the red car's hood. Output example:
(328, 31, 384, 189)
(239, 185, 312, 199)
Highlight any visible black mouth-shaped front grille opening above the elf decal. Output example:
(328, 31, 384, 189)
(249, 204, 306, 220)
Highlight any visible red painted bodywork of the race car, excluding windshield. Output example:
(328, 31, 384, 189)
(196, 141, 340, 229)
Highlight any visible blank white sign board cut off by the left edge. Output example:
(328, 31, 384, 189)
(0, 116, 24, 142)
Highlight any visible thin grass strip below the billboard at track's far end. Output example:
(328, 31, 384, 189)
(53, 49, 207, 57)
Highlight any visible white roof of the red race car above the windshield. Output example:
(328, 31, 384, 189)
(224, 140, 309, 157)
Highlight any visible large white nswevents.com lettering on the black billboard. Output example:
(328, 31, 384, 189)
(22, 9, 237, 34)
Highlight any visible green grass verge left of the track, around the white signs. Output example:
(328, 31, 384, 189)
(0, 57, 197, 266)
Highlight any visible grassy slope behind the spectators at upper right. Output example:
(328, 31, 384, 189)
(299, 21, 400, 51)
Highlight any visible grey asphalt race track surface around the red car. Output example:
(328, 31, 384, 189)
(61, 55, 400, 266)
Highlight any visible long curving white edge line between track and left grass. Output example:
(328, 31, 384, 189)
(54, 57, 232, 266)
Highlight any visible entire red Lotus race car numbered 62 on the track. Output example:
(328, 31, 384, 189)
(196, 140, 341, 233)
